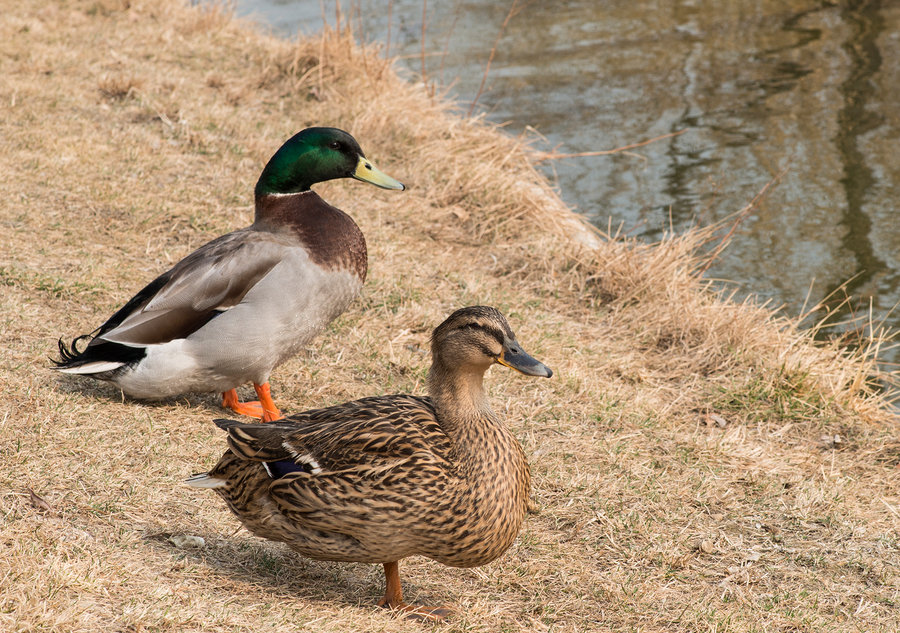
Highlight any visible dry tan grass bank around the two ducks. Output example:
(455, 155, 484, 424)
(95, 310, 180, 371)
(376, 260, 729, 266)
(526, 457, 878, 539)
(0, 0, 900, 632)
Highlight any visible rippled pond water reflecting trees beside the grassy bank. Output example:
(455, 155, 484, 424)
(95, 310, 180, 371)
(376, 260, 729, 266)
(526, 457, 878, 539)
(237, 0, 900, 370)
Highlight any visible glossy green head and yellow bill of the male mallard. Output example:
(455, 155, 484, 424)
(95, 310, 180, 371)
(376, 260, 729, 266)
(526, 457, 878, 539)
(256, 127, 405, 197)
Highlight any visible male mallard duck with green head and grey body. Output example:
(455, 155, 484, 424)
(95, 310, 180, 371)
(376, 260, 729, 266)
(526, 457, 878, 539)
(55, 127, 404, 421)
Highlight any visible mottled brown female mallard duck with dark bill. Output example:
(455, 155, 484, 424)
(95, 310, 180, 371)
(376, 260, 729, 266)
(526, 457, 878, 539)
(188, 306, 553, 619)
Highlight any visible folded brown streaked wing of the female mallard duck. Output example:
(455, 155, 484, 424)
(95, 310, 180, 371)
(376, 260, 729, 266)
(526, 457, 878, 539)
(210, 395, 454, 538)
